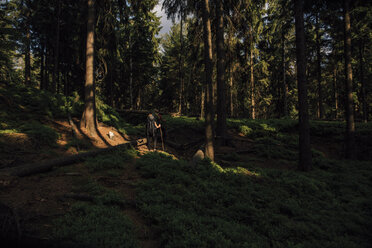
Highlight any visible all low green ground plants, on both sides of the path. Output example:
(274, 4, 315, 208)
(0, 82, 372, 248)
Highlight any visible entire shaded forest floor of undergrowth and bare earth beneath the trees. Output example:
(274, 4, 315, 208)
(0, 84, 372, 248)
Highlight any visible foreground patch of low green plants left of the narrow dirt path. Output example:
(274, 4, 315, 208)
(52, 166, 139, 248)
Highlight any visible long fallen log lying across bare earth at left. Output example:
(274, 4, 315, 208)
(0, 140, 137, 177)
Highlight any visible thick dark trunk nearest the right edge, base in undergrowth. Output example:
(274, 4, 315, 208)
(344, 0, 355, 159)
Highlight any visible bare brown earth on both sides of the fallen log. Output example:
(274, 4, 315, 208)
(0, 119, 159, 247)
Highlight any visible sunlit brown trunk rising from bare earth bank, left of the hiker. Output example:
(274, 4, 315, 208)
(80, 0, 97, 136)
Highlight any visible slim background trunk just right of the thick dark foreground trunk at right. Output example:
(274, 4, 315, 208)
(315, 13, 323, 119)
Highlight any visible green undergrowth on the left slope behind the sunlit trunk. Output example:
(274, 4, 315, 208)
(0, 84, 138, 138)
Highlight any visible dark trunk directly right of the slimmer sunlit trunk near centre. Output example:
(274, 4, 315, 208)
(216, 1, 227, 140)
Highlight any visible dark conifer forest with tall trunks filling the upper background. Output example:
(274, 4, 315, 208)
(0, 0, 372, 163)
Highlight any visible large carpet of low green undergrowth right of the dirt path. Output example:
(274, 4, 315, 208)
(137, 153, 372, 248)
